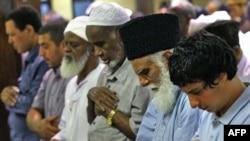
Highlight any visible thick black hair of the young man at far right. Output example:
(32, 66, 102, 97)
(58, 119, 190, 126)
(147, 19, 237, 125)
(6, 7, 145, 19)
(168, 30, 237, 87)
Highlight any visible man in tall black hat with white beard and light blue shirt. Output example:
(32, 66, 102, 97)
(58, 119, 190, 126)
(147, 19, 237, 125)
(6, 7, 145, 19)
(119, 14, 201, 141)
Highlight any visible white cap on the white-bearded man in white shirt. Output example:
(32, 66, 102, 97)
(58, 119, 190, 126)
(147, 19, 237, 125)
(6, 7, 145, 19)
(64, 16, 89, 41)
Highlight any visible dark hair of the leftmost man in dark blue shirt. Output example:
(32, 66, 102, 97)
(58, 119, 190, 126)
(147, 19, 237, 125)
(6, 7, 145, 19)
(5, 5, 42, 32)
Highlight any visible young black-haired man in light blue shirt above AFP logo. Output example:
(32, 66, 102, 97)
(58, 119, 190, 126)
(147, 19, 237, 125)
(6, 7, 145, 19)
(169, 31, 250, 141)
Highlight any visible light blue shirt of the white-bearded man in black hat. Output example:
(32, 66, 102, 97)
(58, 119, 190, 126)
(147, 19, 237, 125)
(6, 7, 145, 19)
(136, 89, 202, 141)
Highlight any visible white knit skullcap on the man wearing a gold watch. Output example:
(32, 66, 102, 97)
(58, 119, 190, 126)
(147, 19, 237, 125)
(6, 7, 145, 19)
(87, 2, 132, 26)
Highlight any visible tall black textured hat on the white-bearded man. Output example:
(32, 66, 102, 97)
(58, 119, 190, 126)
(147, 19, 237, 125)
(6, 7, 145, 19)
(119, 14, 180, 60)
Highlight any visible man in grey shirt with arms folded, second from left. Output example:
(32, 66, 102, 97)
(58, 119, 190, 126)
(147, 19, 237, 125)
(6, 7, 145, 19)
(27, 21, 70, 140)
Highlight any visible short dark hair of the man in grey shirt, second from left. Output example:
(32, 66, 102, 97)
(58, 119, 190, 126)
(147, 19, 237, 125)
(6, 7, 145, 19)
(38, 20, 67, 45)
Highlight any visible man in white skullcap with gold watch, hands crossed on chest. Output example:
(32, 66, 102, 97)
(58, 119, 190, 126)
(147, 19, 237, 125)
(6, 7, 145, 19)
(86, 3, 152, 141)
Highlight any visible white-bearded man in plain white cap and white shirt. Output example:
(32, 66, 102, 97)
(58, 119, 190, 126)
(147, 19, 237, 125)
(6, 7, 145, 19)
(52, 16, 104, 141)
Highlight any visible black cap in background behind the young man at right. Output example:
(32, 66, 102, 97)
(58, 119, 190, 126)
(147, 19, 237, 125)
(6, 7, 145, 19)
(204, 20, 240, 47)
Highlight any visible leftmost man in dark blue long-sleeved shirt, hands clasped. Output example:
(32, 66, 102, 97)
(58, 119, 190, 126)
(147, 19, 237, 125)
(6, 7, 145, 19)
(1, 6, 49, 141)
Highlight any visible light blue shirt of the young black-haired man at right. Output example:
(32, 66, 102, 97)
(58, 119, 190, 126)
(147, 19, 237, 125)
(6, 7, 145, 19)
(193, 87, 250, 141)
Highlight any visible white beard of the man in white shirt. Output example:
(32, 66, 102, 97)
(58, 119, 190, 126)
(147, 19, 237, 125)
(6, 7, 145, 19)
(60, 51, 89, 78)
